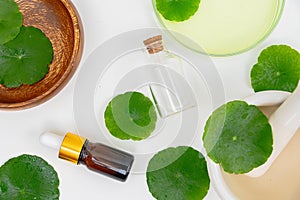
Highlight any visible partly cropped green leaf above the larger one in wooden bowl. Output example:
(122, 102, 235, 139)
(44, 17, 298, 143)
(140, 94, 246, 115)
(0, 0, 23, 44)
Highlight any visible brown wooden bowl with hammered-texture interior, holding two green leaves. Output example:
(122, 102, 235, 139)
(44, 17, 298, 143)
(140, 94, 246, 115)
(0, 0, 83, 110)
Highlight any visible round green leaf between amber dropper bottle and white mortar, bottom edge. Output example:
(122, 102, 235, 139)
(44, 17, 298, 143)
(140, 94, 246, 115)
(146, 146, 210, 200)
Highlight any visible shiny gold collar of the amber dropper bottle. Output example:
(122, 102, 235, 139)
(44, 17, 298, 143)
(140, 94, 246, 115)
(58, 133, 86, 164)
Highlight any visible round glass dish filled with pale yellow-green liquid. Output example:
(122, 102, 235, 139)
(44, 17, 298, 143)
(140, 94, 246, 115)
(153, 0, 284, 56)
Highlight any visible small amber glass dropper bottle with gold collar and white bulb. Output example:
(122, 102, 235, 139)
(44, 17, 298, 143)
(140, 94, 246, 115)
(40, 132, 134, 181)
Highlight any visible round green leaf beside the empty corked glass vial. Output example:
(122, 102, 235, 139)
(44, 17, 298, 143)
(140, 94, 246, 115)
(104, 92, 157, 140)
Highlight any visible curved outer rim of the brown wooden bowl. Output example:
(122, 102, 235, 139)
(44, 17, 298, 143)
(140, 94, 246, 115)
(0, 0, 84, 110)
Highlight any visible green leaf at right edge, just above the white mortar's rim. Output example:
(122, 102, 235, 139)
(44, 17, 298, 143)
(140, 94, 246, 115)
(251, 45, 300, 92)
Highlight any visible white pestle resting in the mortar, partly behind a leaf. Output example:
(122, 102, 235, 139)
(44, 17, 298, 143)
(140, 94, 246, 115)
(246, 81, 300, 177)
